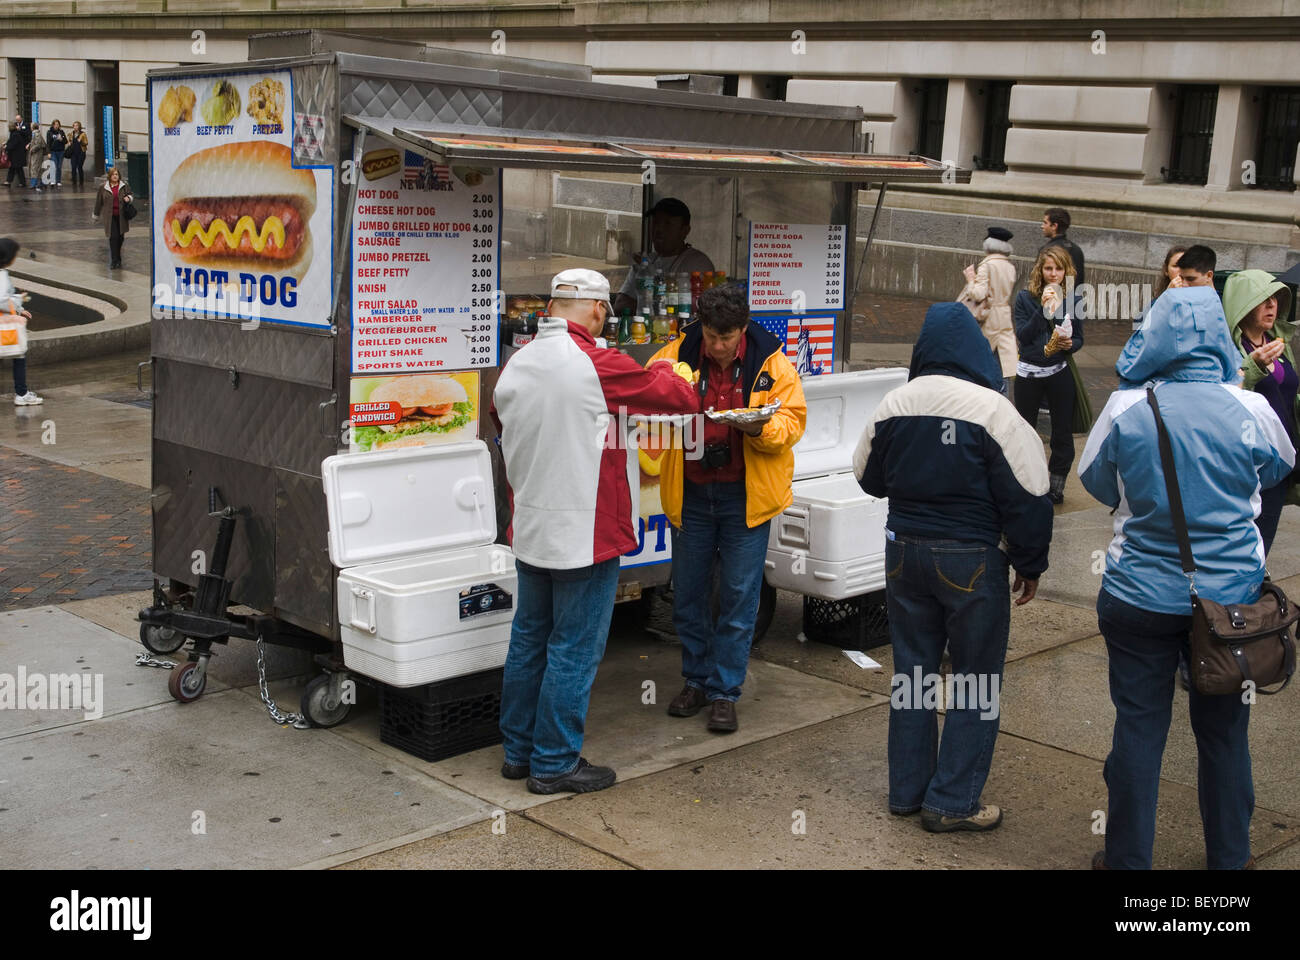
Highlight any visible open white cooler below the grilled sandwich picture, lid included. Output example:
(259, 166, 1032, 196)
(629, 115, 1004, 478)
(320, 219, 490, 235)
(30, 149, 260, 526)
(321, 440, 516, 687)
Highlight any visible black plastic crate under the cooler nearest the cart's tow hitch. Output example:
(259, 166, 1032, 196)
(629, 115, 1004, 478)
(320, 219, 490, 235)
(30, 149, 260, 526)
(380, 667, 504, 761)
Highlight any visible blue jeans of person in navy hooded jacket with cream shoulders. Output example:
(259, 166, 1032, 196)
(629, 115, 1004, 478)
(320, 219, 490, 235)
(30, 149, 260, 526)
(885, 536, 1011, 817)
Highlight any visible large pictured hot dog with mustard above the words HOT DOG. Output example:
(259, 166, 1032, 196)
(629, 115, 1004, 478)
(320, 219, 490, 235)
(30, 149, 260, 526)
(163, 140, 316, 280)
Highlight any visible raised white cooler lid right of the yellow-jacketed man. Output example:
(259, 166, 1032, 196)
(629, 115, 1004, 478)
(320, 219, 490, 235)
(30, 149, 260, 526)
(794, 367, 907, 480)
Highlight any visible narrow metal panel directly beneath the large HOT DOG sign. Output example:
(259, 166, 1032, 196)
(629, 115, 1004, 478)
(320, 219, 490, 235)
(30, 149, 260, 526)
(151, 317, 334, 388)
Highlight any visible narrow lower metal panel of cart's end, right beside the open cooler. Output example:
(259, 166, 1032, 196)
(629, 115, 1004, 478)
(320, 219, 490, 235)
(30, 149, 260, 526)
(274, 470, 337, 636)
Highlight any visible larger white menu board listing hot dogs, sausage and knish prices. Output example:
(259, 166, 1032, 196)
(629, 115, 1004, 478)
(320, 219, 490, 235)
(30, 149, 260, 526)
(352, 147, 501, 375)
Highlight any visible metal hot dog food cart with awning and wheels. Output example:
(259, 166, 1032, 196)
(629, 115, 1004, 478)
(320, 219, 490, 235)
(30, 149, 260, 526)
(140, 31, 970, 723)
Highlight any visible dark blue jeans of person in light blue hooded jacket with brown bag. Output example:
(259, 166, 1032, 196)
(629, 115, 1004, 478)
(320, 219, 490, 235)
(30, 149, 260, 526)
(1097, 589, 1255, 870)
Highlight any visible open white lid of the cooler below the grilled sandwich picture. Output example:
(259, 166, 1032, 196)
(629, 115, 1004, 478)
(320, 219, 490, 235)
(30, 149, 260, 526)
(321, 440, 497, 568)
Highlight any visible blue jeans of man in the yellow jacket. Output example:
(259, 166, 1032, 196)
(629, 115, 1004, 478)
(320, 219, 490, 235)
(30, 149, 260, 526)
(672, 480, 771, 702)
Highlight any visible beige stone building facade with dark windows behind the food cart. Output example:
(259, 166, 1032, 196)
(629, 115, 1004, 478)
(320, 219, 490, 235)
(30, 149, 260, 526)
(0, 0, 1300, 298)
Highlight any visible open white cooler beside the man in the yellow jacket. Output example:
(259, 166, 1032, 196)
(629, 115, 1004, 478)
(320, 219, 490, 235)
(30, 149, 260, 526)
(766, 367, 907, 600)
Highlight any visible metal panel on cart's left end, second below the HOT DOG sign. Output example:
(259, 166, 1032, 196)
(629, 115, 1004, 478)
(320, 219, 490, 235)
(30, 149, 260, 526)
(153, 360, 337, 476)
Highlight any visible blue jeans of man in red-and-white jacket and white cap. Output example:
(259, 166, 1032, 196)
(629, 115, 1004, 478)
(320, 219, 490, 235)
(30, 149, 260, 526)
(501, 557, 619, 778)
